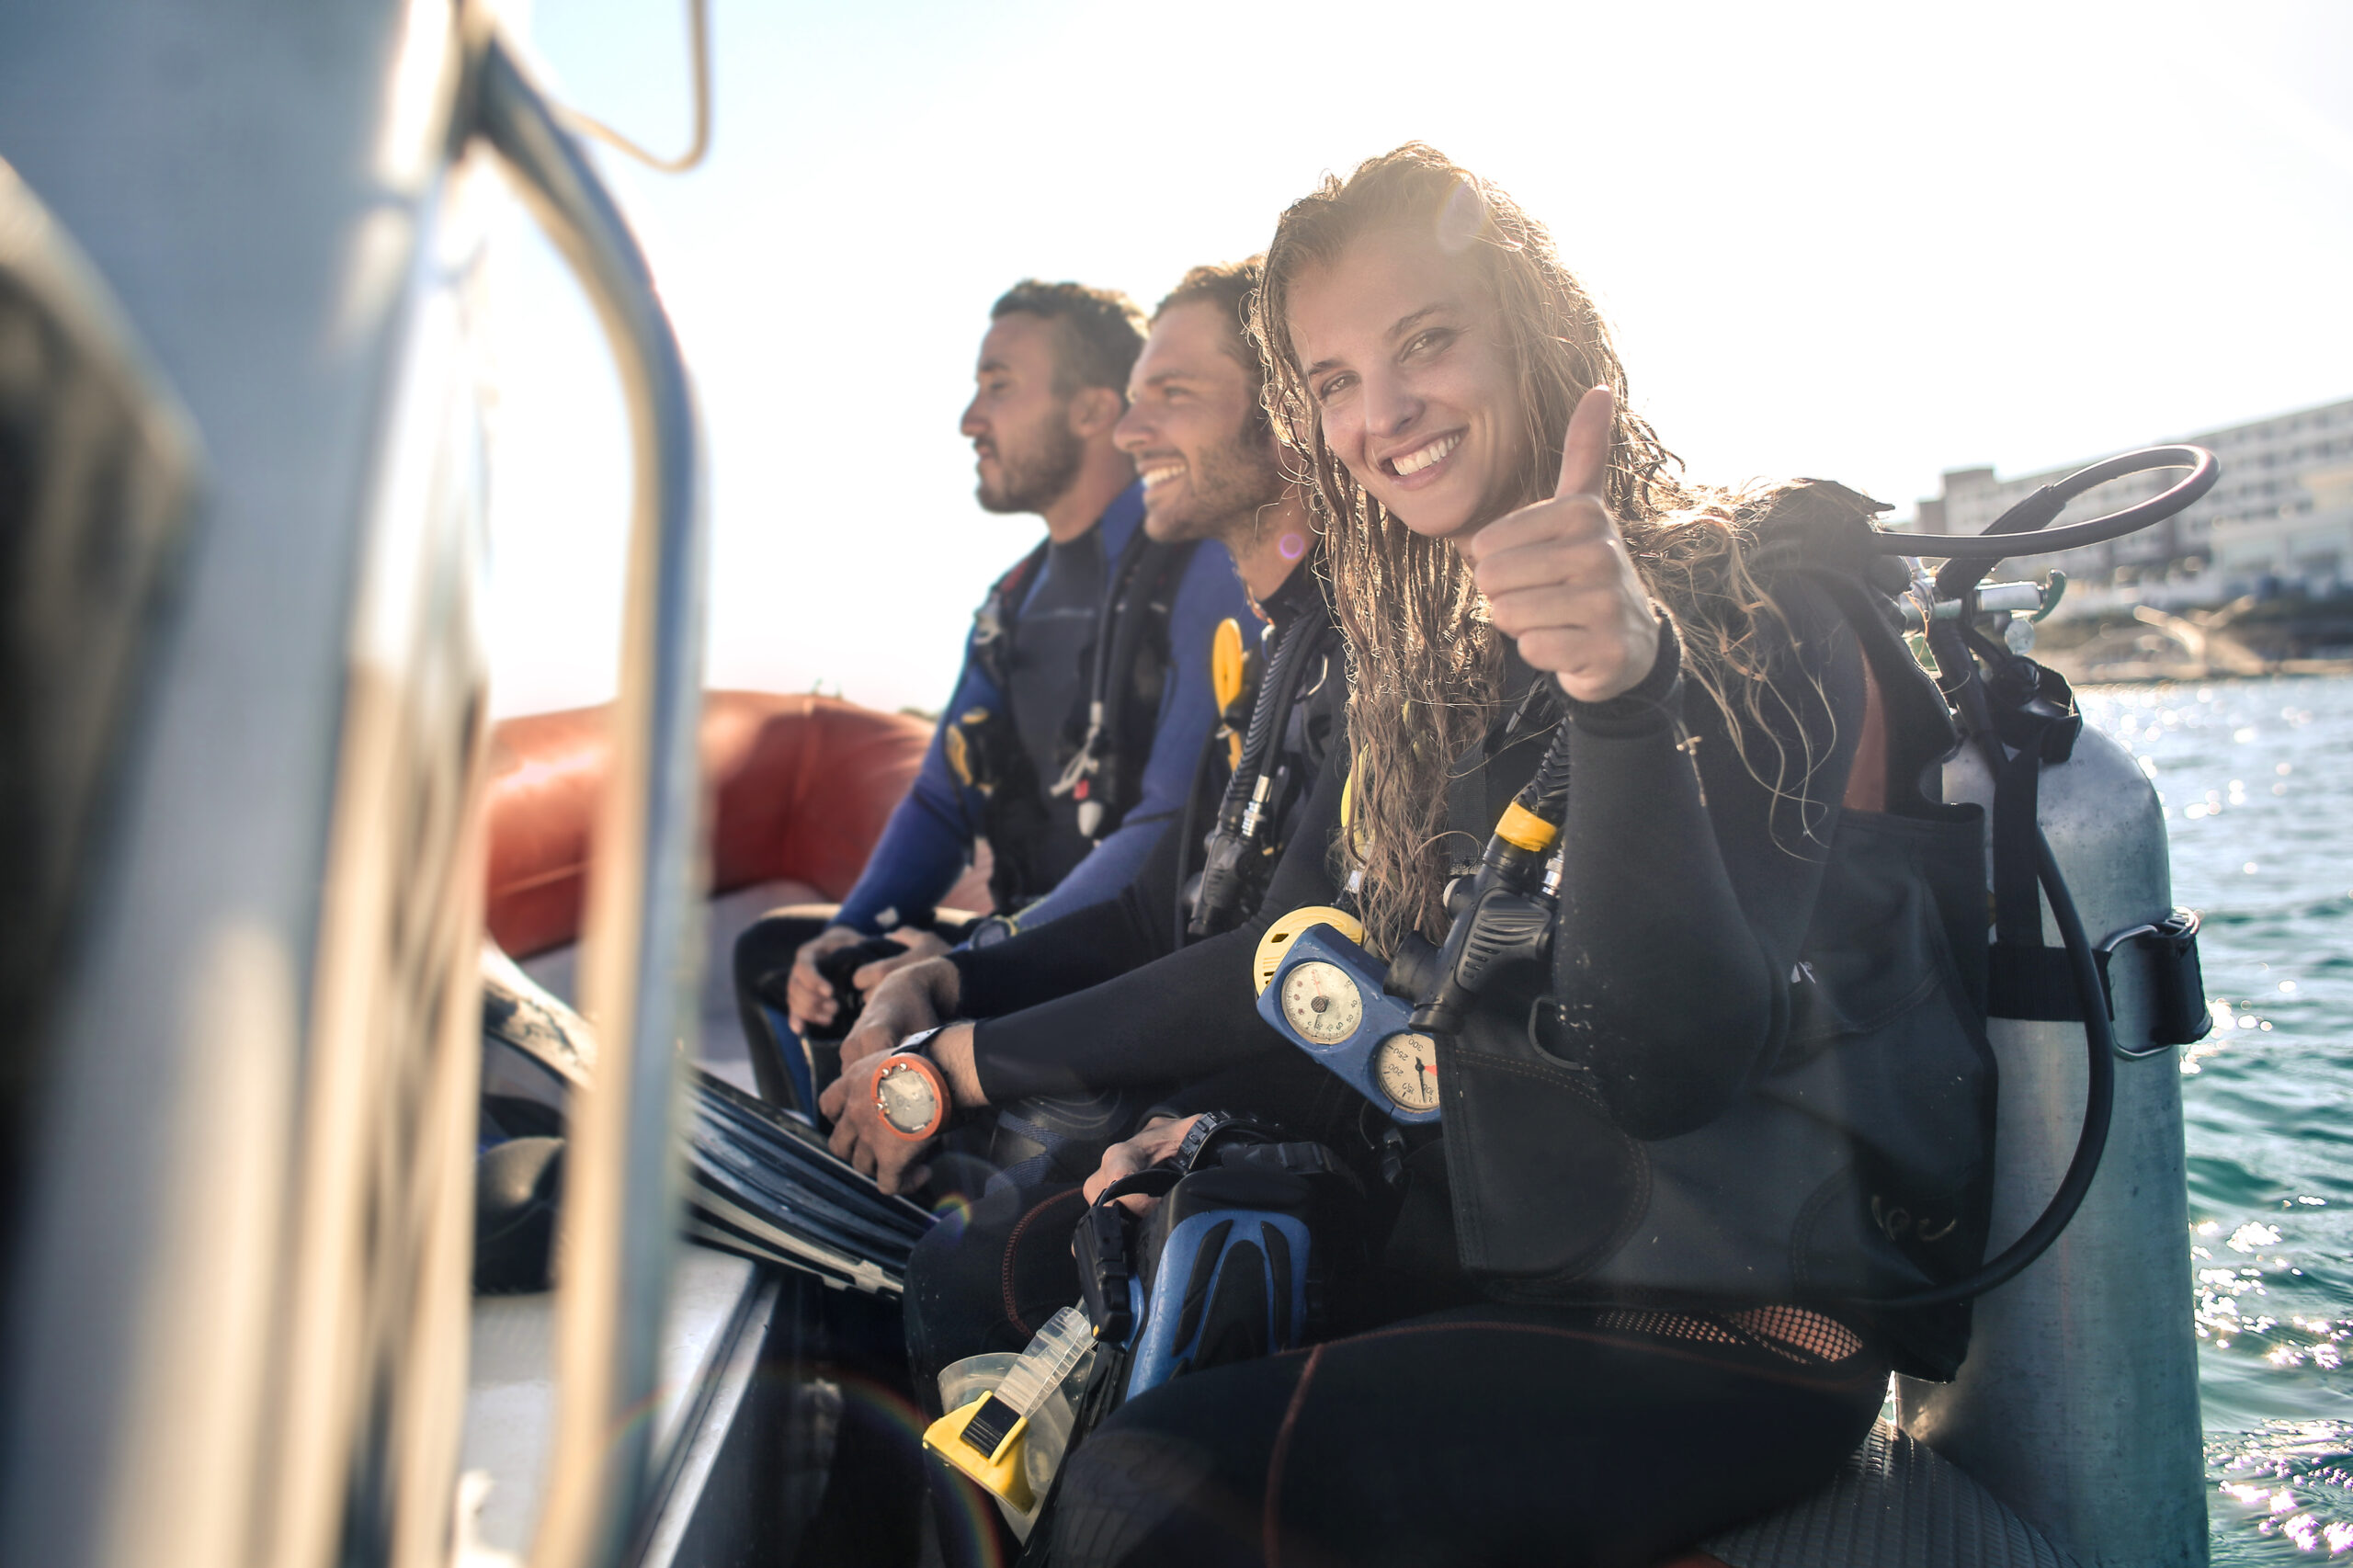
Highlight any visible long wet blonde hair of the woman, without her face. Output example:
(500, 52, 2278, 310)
(1252, 142, 1765, 951)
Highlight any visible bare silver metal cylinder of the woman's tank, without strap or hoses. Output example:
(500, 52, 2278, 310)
(1896, 728, 2207, 1568)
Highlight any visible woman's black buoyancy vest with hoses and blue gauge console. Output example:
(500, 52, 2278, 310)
(1261, 448, 2214, 1393)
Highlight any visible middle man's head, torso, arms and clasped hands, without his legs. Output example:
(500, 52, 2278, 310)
(821, 261, 1346, 1187)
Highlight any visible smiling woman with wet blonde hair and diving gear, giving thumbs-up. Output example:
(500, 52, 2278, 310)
(1054, 143, 1993, 1568)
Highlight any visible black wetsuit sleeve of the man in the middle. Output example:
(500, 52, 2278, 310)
(972, 758, 1348, 1104)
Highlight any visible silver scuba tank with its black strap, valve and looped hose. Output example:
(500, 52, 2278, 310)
(1896, 448, 2217, 1565)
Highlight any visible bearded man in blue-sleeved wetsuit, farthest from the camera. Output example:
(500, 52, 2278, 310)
(736, 280, 1243, 1107)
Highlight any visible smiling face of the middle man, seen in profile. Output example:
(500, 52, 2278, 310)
(1113, 299, 1282, 541)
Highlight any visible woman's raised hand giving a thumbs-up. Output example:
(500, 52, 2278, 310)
(1463, 386, 1659, 701)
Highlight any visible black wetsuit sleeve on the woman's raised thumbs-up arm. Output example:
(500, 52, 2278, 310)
(1553, 579, 1864, 1137)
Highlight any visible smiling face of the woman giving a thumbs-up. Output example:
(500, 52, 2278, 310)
(1290, 231, 1537, 544)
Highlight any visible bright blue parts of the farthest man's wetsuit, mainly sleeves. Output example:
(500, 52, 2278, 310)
(835, 485, 1247, 935)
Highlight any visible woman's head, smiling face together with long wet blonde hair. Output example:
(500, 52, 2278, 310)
(1256, 148, 1753, 942)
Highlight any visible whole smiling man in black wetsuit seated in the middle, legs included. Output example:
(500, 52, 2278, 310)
(824, 259, 1346, 1563)
